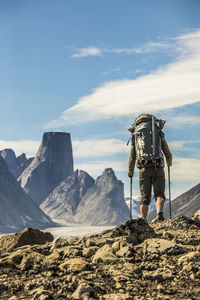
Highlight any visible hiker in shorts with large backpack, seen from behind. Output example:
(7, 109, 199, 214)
(128, 114, 172, 221)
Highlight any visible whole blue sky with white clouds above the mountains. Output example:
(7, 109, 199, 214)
(0, 0, 200, 202)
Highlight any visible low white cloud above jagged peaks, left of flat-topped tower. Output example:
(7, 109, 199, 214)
(0, 140, 40, 157)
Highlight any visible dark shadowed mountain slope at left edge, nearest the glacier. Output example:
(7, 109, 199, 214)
(0, 156, 53, 233)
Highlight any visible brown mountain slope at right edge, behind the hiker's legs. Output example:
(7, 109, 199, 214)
(148, 183, 200, 221)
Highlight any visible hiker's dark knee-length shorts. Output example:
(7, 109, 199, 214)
(139, 167, 165, 205)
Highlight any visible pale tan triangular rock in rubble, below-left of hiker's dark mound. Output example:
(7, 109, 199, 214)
(92, 245, 118, 263)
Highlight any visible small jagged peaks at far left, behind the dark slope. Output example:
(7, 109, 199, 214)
(0, 149, 33, 178)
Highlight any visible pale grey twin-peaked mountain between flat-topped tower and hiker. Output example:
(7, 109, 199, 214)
(40, 169, 129, 225)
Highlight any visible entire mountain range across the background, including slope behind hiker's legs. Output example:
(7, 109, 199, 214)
(0, 132, 200, 231)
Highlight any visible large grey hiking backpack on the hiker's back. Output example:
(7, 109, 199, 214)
(129, 114, 165, 169)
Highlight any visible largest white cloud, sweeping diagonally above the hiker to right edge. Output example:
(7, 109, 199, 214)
(46, 30, 200, 128)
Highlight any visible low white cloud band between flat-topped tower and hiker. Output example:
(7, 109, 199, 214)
(72, 139, 127, 157)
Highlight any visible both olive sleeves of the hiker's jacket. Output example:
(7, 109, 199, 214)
(129, 132, 172, 174)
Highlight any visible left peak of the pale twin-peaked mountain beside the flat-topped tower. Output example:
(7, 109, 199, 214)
(40, 170, 94, 221)
